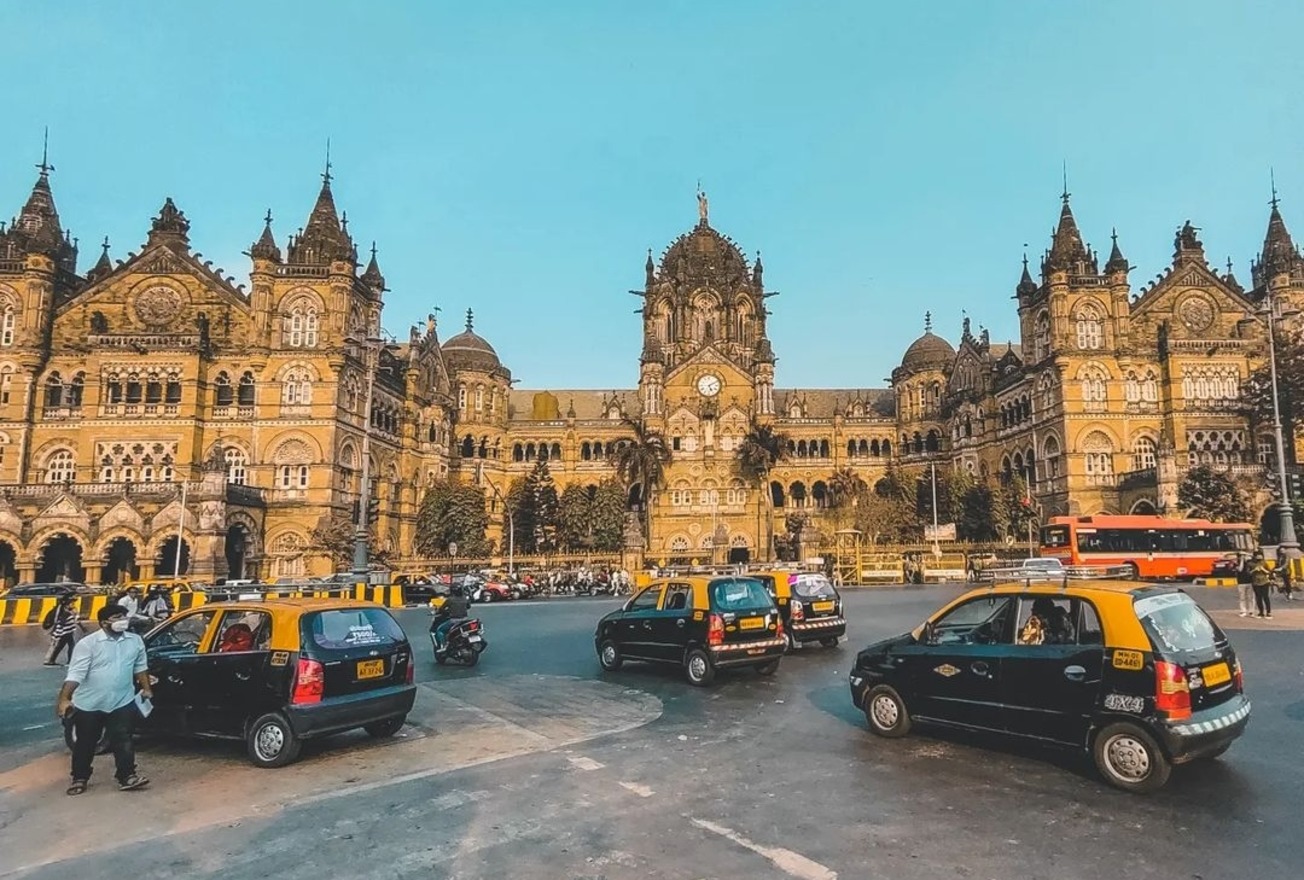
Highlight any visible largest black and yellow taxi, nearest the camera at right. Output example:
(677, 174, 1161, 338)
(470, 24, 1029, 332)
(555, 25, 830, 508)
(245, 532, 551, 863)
(850, 580, 1251, 793)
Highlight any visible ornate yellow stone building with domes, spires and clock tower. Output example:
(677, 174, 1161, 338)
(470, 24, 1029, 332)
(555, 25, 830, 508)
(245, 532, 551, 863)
(0, 158, 1304, 583)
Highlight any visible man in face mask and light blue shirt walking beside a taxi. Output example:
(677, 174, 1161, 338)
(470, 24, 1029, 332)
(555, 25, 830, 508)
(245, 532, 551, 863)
(55, 605, 154, 794)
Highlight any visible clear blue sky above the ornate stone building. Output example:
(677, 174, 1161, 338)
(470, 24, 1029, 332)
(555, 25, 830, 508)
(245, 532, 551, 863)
(0, 0, 1304, 387)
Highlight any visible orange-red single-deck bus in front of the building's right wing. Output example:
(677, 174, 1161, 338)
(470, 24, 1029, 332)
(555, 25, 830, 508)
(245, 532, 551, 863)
(1042, 515, 1254, 578)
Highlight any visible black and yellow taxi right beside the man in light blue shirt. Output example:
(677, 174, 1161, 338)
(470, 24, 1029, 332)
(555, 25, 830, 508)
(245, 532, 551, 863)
(141, 598, 416, 767)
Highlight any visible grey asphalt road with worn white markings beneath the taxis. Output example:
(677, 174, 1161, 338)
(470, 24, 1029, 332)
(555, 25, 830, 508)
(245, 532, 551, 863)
(0, 587, 1304, 880)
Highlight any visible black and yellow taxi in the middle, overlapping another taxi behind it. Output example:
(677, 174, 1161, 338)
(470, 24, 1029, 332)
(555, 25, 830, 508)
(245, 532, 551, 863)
(593, 575, 786, 687)
